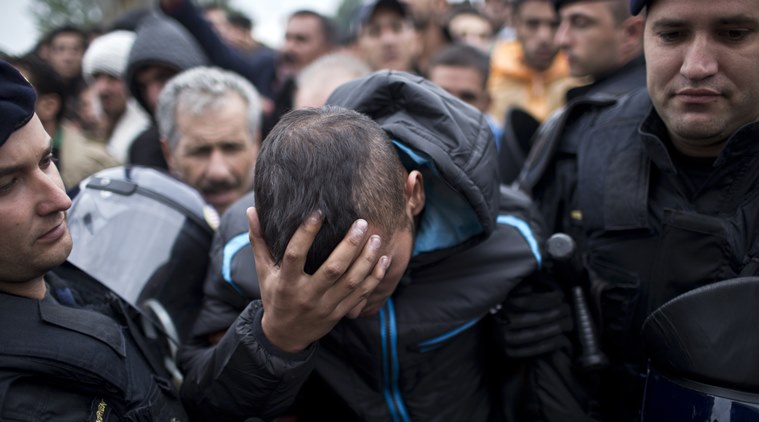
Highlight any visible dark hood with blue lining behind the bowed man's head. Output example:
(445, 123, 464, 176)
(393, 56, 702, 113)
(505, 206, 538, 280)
(327, 70, 498, 258)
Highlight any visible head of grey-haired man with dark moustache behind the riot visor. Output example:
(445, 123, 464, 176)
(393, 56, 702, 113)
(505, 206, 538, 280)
(156, 67, 261, 215)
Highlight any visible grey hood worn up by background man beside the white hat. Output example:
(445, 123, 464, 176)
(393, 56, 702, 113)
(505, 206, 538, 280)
(125, 13, 209, 115)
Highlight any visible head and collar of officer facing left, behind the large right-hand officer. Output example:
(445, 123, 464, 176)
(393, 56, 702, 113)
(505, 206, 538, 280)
(555, 0, 646, 101)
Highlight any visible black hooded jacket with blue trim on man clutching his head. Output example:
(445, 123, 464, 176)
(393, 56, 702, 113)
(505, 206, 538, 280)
(180, 71, 540, 421)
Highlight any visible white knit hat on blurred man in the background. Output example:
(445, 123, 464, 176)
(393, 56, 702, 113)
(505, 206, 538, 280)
(82, 31, 135, 84)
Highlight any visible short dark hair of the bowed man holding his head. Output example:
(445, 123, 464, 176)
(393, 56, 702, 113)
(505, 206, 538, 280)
(253, 106, 408, 274)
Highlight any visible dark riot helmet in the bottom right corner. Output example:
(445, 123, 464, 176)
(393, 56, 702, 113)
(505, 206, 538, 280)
(641, 277, 759, 422)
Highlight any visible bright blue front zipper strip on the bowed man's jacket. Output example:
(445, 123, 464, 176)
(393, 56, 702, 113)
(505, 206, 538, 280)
(379, 298, 410, 422)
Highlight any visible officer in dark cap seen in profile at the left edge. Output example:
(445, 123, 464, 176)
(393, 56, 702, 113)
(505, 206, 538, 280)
(0, 62, 187, 421)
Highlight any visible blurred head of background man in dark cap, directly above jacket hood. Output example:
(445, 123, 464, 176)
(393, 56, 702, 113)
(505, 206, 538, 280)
(354, 0, 419, 72)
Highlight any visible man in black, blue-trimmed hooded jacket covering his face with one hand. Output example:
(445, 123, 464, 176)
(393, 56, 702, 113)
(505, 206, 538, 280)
(180, 71, 541, 421)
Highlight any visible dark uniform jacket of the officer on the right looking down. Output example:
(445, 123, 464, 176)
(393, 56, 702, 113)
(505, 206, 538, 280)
(520, 90, 759, 421)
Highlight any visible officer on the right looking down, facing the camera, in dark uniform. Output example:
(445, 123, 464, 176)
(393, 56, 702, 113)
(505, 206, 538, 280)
(519, 0, 759, 421)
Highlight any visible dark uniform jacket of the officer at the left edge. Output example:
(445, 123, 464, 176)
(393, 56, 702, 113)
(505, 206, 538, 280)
(0, 265, 187, 421)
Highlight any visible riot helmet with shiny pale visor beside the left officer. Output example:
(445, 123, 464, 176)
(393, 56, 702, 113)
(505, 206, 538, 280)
(68, 166, 218, 355)
